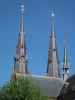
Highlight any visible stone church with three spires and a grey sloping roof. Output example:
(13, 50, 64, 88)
(12, 1, 72, 100)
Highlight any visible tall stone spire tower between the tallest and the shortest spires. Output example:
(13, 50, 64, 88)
(47, 12, 60, 78)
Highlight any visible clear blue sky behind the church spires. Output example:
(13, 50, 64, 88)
(0, 0, 75, 84)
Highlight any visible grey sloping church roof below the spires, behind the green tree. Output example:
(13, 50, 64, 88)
(14, 74, 65, 97)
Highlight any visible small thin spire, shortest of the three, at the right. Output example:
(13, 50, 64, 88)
(63, 34, 70, 81)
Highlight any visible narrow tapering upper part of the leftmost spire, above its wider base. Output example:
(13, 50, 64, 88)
(16, 4, 26, 57)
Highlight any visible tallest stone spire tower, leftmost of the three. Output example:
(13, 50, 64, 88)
(14, 1, 28, 74)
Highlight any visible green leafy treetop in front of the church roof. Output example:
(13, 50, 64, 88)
(0, 78, 48, 100)
